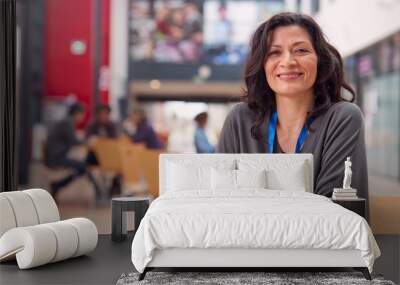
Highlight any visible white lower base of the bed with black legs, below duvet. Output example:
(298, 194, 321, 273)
(139, 248, 371, 280)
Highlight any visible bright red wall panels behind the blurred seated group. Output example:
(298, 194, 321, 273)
(44, 0, 110, 124)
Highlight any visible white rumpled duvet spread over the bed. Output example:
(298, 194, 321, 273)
(132, 189, 380, 272)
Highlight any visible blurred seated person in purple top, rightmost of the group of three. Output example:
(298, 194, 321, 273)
(124, 106, 164, 149)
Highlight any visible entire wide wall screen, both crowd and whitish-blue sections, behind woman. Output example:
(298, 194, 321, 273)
(129, 0, 284, 65)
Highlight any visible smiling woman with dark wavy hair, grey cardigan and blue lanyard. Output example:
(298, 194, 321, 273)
(217, 13, 368, 204)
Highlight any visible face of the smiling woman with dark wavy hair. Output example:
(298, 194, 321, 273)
(264, 25, 318, 97)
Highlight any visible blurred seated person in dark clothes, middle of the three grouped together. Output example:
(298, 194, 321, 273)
(86, 104, 119, 165)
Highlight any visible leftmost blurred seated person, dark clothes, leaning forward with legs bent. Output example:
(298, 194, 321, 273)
(45, 103, 98, 199)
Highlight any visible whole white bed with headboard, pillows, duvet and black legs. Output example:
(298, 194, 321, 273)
(132, 154, 380, 280)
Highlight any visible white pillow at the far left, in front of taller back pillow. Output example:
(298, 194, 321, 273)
(167, 163, 211, 191)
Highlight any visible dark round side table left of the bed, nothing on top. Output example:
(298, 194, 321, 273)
(111, 197, 150, 241)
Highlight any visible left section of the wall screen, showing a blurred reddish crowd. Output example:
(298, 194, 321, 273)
(130, 0, 203, 63)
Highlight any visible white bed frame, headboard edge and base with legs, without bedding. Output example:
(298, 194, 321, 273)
(139, 154, 371, 280)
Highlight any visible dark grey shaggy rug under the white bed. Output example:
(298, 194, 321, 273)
(117, 271, 395, 285)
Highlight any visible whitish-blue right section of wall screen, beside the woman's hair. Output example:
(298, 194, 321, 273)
(203, 0, 283, 64)
